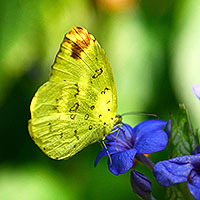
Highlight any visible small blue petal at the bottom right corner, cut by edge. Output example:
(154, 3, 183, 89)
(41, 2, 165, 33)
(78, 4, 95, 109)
(188, 170, 200, 200)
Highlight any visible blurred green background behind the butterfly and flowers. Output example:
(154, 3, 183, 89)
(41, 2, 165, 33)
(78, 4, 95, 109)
(0, 0, 200, 200)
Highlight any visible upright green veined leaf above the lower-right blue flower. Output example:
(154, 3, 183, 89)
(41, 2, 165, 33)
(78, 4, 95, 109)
(169, 104, 199, 158)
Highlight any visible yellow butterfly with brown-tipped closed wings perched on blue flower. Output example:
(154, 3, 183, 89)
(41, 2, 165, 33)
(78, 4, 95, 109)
(28, 27, 121, 160)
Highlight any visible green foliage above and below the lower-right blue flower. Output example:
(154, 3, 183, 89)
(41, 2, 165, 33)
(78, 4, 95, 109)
(166, 104, 199, 200)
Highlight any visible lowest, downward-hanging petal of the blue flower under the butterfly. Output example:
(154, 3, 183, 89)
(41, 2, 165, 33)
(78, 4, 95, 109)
(108, 149, 137, 175)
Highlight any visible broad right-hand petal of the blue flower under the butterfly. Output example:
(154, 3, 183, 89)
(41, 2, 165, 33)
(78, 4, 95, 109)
(133, 120, 168, 154)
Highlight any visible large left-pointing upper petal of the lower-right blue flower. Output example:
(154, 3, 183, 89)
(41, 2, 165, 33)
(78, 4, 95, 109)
(153, 155, 200, 186)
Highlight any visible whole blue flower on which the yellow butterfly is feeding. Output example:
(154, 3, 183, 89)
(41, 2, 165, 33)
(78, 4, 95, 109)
(95, 120, 168, 175)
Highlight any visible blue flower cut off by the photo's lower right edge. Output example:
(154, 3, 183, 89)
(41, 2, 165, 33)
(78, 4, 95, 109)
(153, 153, 200, 200)
